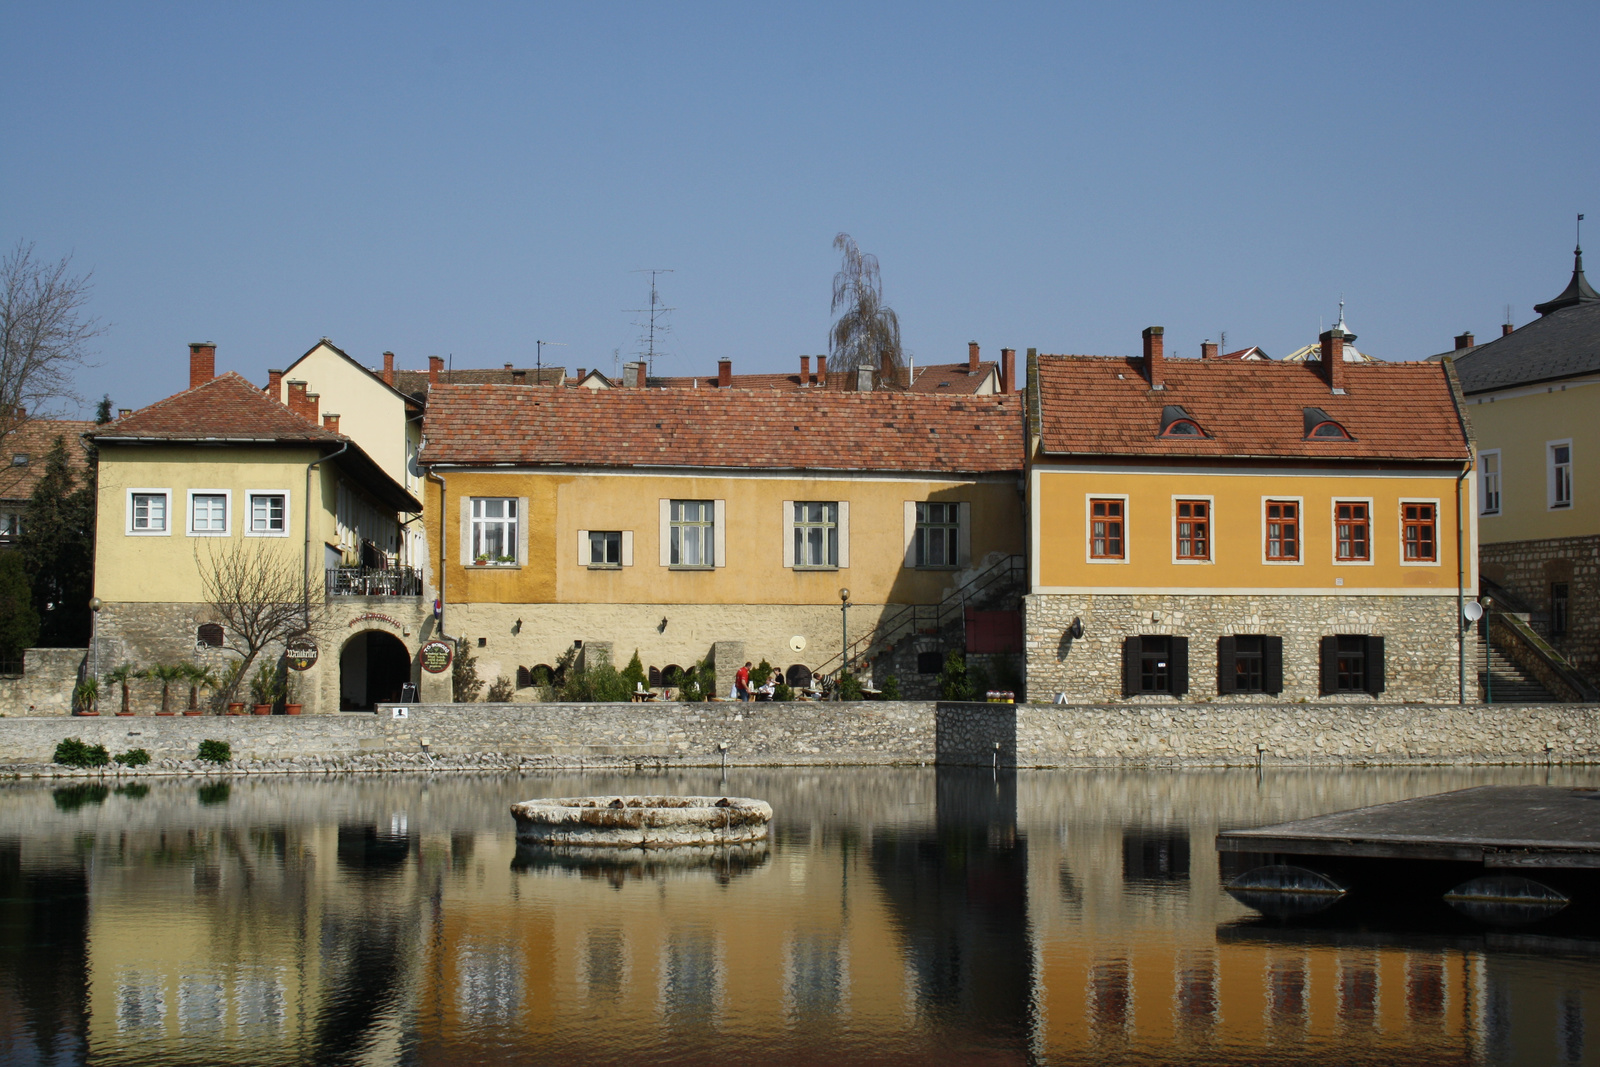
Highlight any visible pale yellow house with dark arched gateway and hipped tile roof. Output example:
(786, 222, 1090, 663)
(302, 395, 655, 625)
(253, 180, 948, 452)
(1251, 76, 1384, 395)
(86, 346, 430, 712)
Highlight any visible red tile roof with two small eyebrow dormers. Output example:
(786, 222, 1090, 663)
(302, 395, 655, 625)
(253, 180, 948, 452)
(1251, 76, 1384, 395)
(1038, 355, 1469, 461)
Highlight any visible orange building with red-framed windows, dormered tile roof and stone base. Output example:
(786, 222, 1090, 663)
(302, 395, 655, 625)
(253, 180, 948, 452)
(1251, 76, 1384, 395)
(1026, 326, 1477, 702)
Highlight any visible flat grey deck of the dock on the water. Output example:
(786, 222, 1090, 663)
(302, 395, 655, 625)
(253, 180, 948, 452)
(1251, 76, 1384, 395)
(1216, 785, 1600, 869)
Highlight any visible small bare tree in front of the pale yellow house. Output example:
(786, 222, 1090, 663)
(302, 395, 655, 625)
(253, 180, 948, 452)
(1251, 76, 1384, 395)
(195, 539, 325, 702)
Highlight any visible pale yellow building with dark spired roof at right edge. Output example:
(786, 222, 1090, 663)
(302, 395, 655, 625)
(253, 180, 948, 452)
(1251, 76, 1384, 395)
(1454, 250, 1600, 681)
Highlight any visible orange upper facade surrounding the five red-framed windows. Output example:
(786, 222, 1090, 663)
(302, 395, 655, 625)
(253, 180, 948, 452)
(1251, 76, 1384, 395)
(1030, 464, 1477, 595)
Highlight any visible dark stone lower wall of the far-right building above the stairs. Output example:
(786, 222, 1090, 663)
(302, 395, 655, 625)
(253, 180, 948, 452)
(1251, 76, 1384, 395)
(1478, 536, 1600, 685)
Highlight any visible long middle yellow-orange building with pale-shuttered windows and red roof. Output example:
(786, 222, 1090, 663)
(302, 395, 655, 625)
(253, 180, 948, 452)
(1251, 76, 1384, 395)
(422, 386, 1022, 694)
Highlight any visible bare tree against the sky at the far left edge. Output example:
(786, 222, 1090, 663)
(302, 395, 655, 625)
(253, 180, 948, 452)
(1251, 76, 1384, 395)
(0, 242, 104, 438)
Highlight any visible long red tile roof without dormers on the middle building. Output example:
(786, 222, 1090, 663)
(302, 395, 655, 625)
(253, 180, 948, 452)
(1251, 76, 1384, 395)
(422, 386, 1022, 474)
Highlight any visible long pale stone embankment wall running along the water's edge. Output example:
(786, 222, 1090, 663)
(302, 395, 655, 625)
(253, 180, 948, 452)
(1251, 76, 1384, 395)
(0, 701, 1600, 774)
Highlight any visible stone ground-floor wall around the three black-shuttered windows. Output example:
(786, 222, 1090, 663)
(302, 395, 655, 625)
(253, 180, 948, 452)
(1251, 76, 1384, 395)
(1022, 593, 1472, 705)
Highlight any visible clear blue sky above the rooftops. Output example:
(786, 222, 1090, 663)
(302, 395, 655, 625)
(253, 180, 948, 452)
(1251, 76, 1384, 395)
(0, 0, 1600, 406)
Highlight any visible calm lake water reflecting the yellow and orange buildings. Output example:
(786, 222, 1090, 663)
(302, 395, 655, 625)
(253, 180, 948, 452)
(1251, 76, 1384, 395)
(0, 768, 1600, 1067)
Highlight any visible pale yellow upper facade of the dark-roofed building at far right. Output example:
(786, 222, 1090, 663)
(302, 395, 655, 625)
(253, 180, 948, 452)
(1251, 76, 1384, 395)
(1467, 378, 1600, 544)
